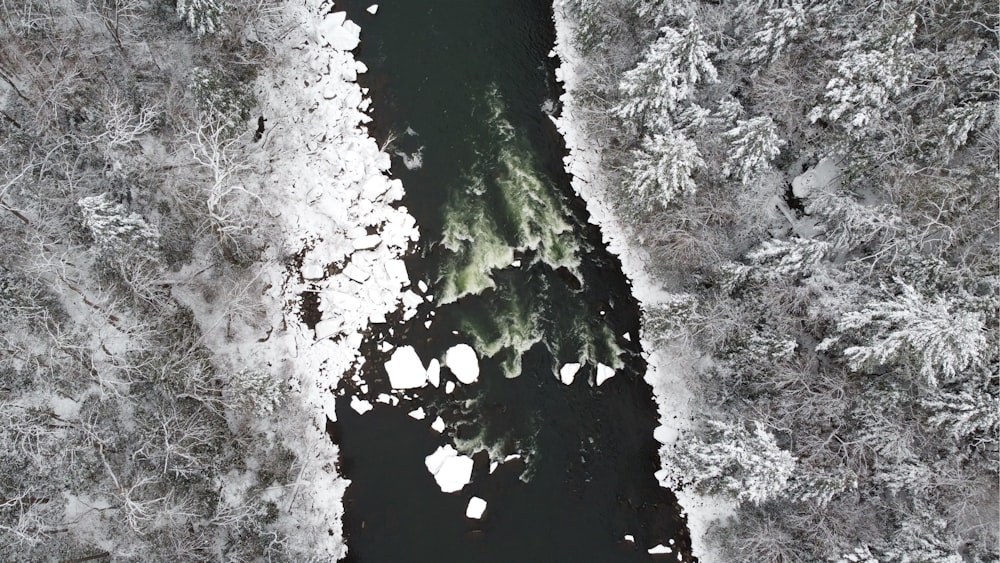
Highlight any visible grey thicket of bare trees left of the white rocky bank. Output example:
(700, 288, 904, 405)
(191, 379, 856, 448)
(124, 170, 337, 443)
(0, 0, 324, 561)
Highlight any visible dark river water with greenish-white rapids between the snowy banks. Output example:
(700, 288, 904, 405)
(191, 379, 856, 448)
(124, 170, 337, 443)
(331, 0, 690, 562)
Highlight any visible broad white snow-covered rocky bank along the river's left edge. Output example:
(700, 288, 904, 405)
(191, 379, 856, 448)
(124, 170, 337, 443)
(183, 0, 418, 560)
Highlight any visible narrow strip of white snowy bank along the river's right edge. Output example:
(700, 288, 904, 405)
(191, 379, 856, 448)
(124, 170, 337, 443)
(554, 0, 733, 563)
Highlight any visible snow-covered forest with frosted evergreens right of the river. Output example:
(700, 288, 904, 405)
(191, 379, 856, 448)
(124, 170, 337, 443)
(557, 0, 1000, 563)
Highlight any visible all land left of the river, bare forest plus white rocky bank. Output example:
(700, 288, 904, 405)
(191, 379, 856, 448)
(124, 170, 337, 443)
(0, 0, 416, 561)
